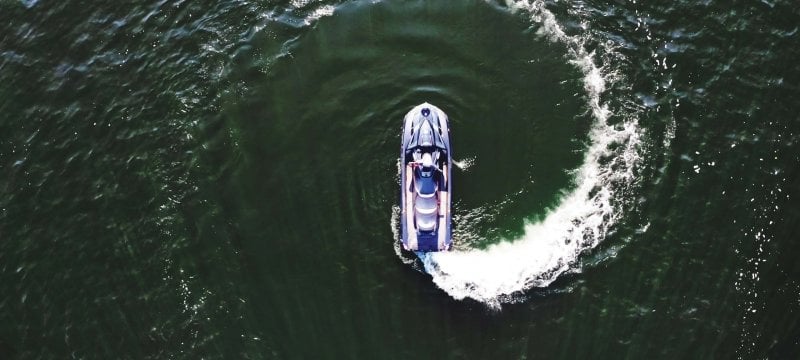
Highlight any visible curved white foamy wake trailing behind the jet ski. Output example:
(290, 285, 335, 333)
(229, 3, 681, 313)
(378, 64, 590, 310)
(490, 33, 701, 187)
(400, 1, 640, 306)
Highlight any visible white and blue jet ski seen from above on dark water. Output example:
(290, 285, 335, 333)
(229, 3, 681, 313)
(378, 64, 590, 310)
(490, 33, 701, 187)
(400, 102, 453, 252)
